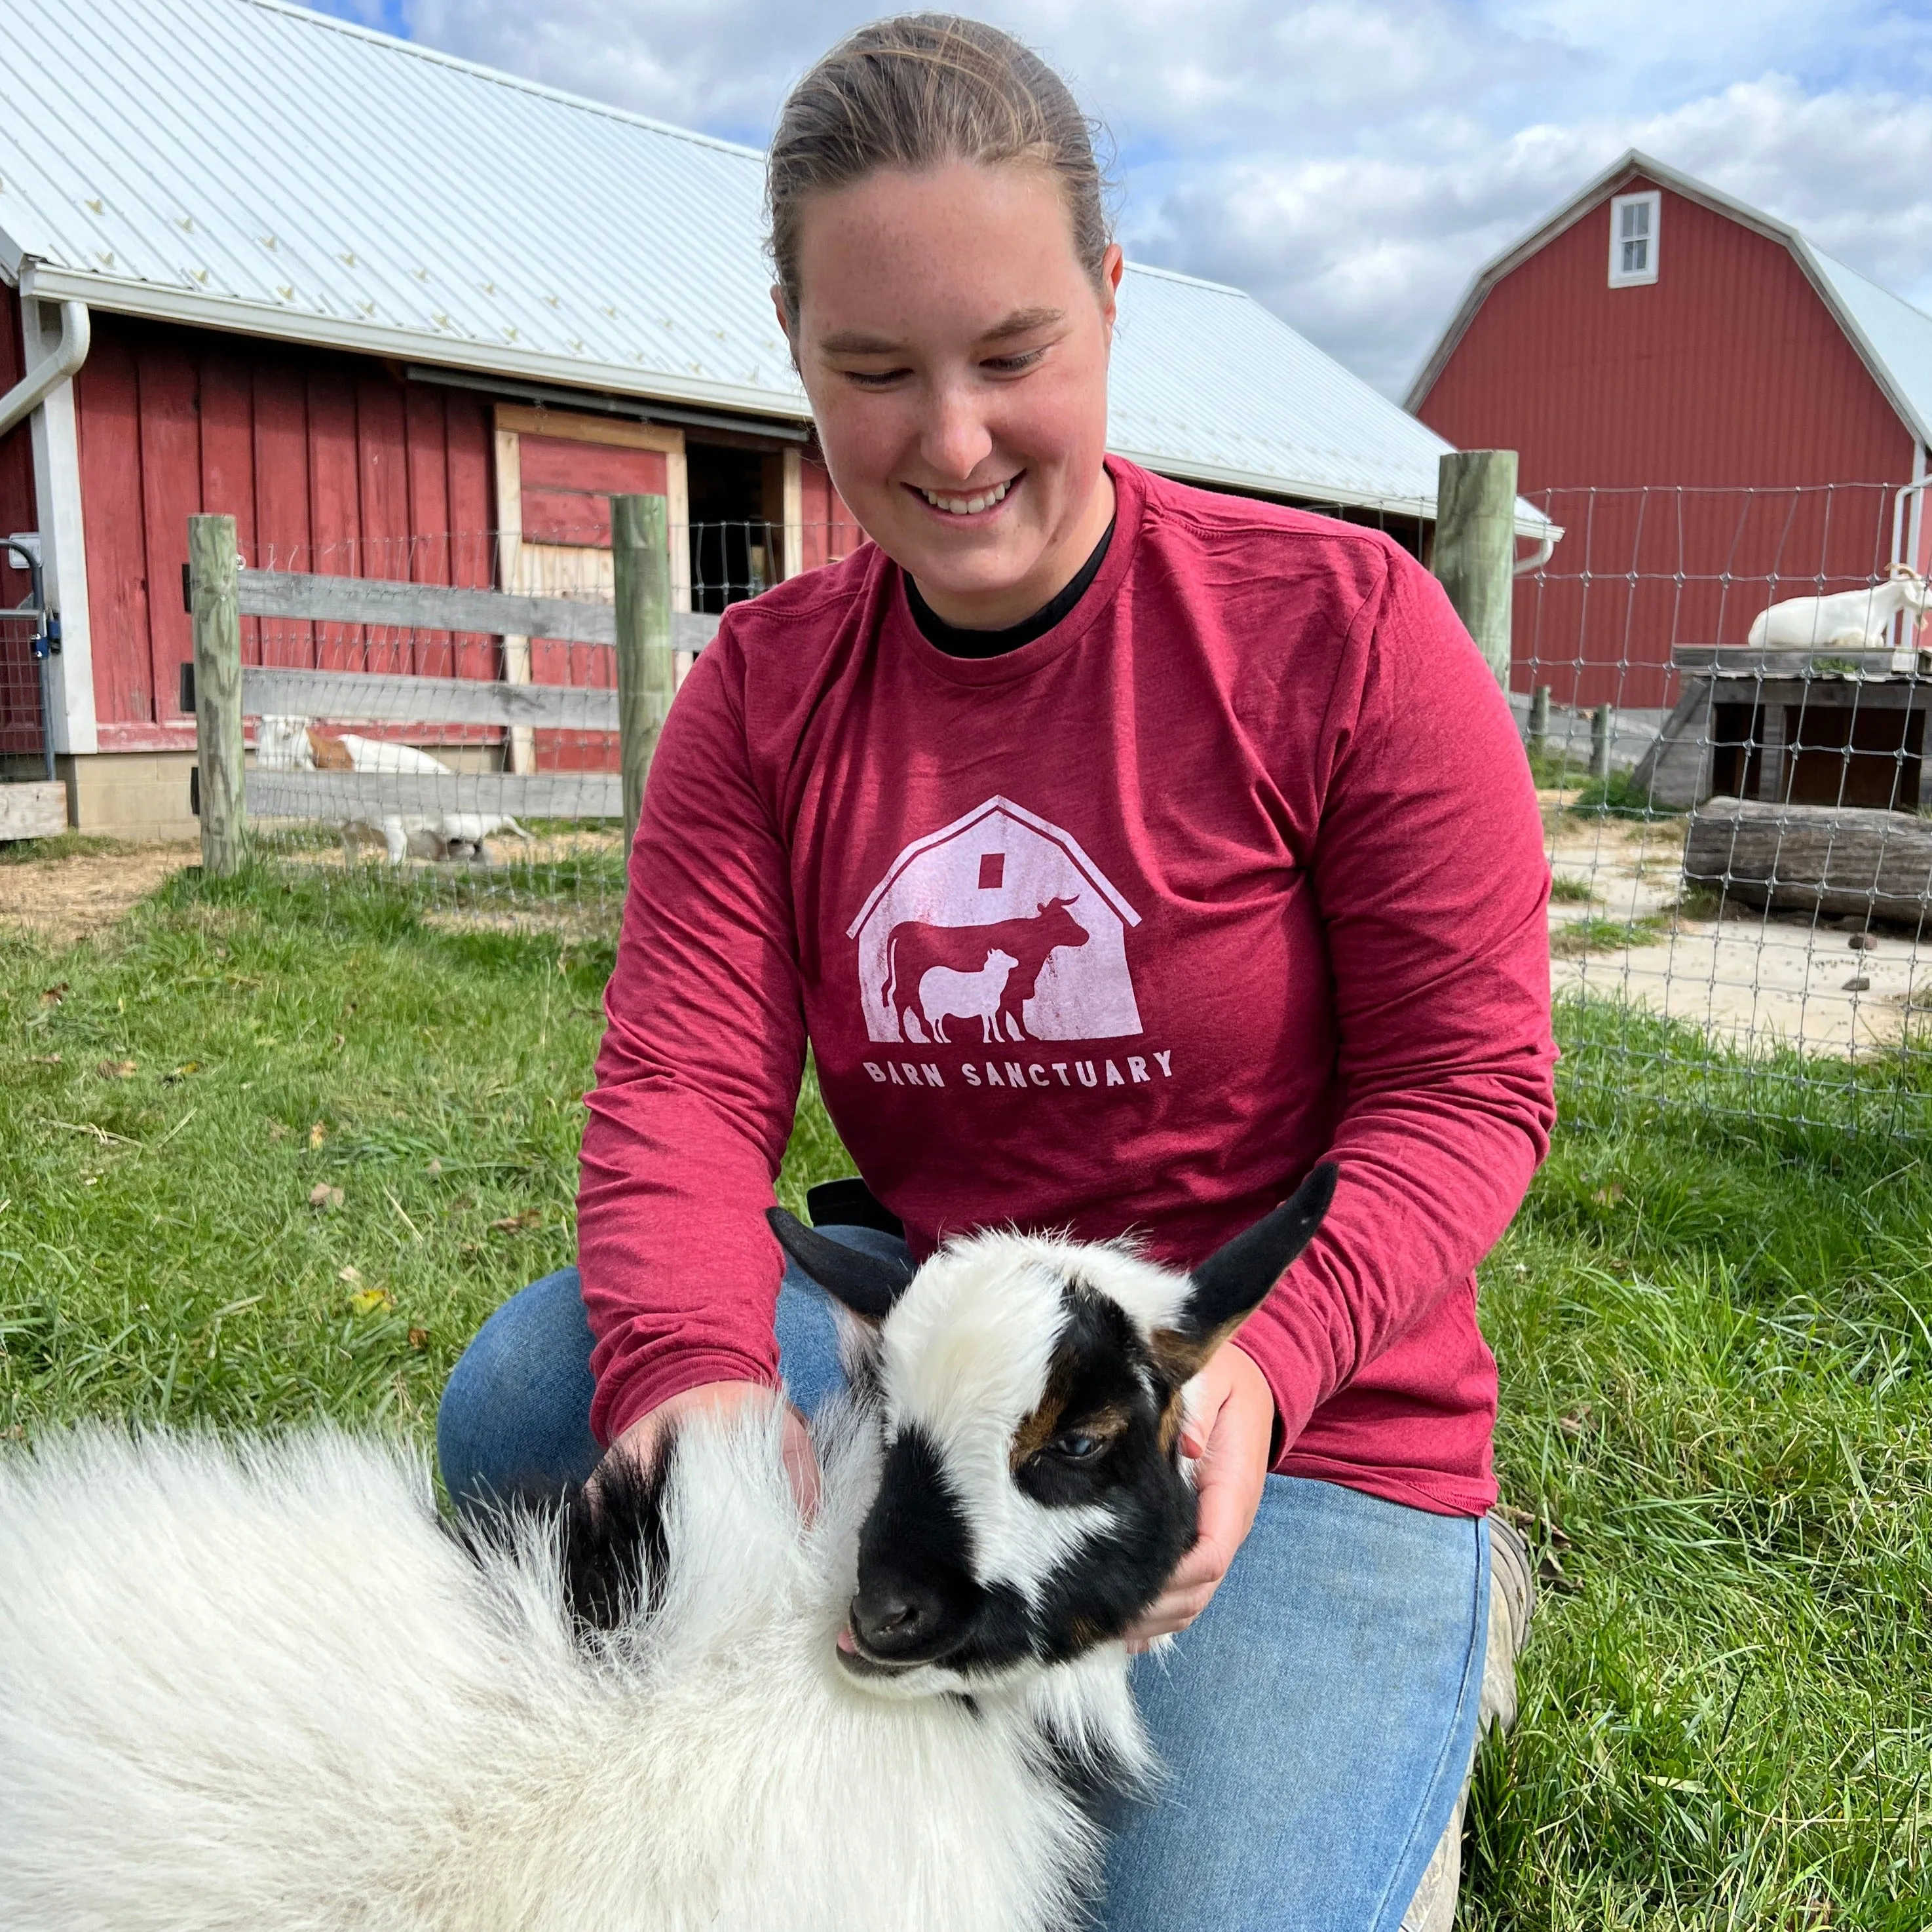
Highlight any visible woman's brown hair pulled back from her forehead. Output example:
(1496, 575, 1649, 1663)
(765, 14, 1113, 321)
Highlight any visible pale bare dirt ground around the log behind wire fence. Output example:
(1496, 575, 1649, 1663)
(1544, 792, 1932, 1059)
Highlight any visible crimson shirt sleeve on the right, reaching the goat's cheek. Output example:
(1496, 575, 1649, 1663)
(1240, 556, 1555, 1449)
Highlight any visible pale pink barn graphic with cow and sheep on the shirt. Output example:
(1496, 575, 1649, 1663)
(846, 798, 1140, 1045)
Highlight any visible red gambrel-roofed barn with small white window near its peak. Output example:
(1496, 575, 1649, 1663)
(1407, 151, 1932, 709)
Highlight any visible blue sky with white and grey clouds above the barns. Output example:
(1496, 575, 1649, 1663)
(309, 0, 1932, 398)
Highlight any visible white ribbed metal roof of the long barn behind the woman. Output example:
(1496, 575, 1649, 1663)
(0, 0, 1544, 531)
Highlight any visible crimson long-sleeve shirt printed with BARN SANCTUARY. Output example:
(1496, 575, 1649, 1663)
(578, 462, 1555, 1515)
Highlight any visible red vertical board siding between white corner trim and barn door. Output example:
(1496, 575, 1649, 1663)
(73, 315, 497, 749)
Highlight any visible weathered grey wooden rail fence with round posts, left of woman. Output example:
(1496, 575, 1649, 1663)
(181, 497, 719, 875)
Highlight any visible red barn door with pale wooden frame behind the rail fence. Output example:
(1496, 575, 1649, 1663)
(497, 404, 692, 771)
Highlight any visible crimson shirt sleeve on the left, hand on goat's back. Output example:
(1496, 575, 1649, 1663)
(578, 628, 806, 1443)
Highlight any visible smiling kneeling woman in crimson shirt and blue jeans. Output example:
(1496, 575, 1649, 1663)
(440, 16, 1553, 1932)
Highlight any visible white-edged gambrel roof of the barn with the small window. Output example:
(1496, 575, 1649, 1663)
(1407, 147, 1932, 442)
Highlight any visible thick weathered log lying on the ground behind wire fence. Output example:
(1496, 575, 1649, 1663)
(1685, 798, 1932, 926)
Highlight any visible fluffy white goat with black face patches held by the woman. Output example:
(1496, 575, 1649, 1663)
(0, 1167, 1335, 1932)
